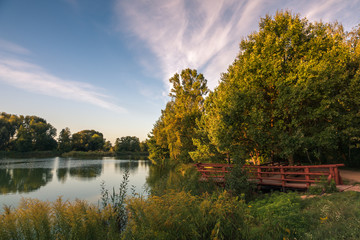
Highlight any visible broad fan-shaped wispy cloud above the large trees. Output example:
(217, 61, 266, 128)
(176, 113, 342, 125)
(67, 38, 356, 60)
(115, 0, 360, 88)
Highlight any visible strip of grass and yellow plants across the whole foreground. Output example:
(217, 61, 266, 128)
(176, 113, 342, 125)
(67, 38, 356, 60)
(0, 191, 360, 240)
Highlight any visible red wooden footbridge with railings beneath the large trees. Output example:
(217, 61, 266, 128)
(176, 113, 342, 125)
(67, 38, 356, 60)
(195, 163, 344, 189)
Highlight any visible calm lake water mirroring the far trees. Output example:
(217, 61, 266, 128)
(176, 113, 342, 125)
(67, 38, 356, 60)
(0, 157, 150, 209)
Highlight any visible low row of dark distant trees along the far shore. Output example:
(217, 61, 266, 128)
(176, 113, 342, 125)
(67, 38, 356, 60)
(0, 112, 148, 153)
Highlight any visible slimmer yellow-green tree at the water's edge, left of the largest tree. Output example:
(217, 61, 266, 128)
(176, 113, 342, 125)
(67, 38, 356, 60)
(149, 69, 208, 163)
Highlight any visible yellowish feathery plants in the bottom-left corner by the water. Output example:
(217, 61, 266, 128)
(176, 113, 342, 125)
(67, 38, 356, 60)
(0, 198, 119, 240)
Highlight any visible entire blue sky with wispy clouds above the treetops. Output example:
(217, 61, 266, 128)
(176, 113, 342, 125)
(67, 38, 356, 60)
(0, 0, 360, 143)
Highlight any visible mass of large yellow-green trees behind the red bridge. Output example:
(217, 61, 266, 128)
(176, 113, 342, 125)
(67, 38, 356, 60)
(149, 11, 360, 166)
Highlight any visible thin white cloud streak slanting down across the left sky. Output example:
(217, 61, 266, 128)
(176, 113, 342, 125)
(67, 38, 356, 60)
(0, 58, 126, 113)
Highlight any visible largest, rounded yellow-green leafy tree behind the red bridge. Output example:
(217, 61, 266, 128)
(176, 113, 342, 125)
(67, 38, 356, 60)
(203, 11, 359, 164)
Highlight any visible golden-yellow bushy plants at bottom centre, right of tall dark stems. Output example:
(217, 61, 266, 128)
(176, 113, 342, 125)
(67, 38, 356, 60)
(125, 191, 247, 239)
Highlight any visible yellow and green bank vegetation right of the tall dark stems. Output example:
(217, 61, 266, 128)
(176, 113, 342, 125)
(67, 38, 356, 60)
(124, 188, 360, 239)
